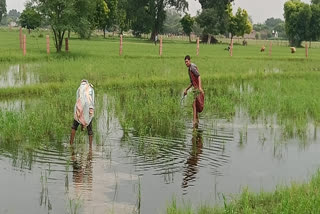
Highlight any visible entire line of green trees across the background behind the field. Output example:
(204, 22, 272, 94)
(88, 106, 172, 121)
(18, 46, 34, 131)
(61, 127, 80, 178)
(0, 0, 320, 52)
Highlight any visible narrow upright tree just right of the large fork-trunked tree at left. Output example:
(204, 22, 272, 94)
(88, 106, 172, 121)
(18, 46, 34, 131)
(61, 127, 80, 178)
(94, 0, 110, 38)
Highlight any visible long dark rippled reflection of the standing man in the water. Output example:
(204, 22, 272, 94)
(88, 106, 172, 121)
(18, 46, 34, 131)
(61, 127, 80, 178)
(182, 129, 203, 188)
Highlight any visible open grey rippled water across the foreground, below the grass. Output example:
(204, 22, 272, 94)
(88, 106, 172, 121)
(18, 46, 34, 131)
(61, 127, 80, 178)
(0, 104, 320, 214)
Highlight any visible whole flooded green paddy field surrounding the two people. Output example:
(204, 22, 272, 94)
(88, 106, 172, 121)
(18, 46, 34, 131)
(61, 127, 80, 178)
(0, 28, 320, 213)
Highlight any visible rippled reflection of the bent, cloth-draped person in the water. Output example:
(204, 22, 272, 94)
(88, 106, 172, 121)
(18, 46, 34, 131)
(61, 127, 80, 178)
(71, 144, 93, 192)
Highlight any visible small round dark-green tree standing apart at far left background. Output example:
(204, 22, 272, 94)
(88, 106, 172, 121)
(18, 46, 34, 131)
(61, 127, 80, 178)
(20, 3, 41, 34)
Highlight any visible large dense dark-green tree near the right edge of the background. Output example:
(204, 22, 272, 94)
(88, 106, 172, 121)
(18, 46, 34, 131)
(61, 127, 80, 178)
(284, 0, 312, 46)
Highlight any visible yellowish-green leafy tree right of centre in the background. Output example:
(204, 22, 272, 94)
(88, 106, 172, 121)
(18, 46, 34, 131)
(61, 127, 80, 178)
(228, 6, 252, 39)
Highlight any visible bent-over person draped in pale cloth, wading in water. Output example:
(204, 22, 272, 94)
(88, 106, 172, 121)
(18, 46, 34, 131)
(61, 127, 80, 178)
(70, 80, 94, 145)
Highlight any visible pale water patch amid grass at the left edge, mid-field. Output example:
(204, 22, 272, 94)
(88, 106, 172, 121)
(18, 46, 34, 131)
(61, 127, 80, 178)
(0, 64, 39, 88)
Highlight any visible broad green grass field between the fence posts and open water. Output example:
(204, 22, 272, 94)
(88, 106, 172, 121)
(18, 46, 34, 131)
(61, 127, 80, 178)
(0, 28, 320, 150)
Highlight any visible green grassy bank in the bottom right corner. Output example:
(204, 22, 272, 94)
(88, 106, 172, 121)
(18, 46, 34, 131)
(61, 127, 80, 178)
(167, 172, 320, 214)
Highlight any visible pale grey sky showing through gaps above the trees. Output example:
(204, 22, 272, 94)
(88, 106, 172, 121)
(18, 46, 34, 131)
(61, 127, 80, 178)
(7, 0, 310, 23)
